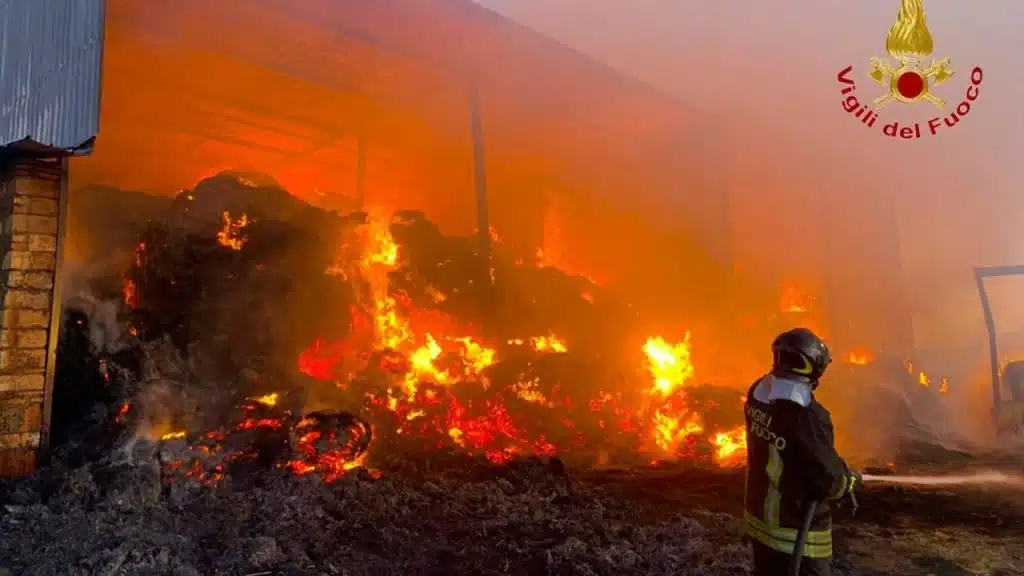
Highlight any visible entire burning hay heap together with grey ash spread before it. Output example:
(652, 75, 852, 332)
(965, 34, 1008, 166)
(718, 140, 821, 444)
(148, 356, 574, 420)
(0, 172, 765, 574)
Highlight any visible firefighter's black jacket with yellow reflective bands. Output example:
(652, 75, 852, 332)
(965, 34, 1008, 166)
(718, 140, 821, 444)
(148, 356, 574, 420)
(743, 374, 852, 558)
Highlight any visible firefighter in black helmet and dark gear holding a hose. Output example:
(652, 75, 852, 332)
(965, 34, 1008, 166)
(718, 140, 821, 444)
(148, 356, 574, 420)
(743, 328, 860, 576)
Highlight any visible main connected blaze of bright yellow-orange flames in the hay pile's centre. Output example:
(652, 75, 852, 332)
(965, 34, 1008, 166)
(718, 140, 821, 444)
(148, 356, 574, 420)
(299, 218, 744, 465)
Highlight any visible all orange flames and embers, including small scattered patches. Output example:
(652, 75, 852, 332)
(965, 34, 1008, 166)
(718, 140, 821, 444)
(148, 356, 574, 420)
(121, 203, 947, 482)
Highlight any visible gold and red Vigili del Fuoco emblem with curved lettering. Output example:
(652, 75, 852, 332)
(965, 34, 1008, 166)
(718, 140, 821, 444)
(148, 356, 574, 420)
(837, 0, 984, 140)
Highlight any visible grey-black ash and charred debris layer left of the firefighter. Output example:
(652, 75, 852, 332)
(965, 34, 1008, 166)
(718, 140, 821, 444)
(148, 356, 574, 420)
(0, 453, 748, 576)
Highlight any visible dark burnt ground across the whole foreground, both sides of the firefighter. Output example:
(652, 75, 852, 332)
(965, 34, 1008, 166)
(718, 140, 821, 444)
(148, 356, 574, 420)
(0, 453, 1024, 576)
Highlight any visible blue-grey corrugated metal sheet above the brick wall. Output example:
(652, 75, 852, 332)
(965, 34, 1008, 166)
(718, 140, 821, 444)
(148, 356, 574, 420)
(0, 0, 105, 151)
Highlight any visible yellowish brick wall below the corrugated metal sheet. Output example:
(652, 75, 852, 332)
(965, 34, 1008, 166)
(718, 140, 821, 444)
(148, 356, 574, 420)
(0, 157, 67, 478)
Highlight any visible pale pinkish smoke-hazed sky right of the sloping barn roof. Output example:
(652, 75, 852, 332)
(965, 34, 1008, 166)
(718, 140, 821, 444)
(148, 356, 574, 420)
(478, 0, 1024, 350)
